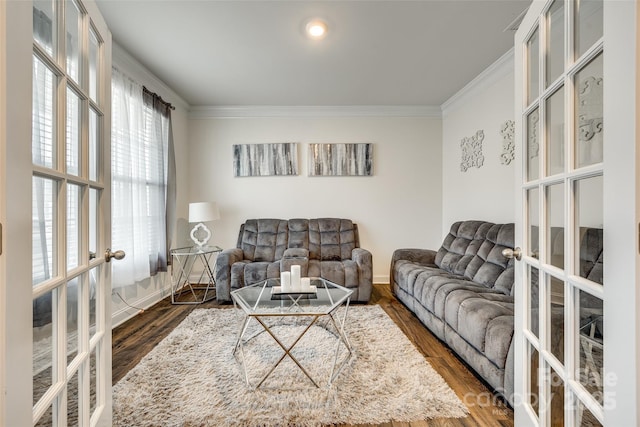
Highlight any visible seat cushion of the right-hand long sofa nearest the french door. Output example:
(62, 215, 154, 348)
(444, 289, 514, 368)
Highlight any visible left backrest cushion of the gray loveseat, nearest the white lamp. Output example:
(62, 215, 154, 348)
(237, 219, 288, 262)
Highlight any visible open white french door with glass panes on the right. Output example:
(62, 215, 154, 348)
(515, 0, 640, 426)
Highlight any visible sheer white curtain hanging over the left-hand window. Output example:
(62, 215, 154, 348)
(111, 68, 168, 287)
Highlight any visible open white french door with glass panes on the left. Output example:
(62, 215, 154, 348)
(0, 0, 111, 426)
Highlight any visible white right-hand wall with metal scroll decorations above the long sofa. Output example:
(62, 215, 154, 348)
(442, 51, 520, 236)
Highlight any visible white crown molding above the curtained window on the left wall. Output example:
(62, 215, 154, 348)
(112, 42, 190, 111)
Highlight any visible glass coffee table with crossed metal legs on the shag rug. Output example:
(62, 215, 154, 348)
(231, 278, 353, 389)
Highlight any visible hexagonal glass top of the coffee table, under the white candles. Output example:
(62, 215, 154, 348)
(231, 277, 353, 316)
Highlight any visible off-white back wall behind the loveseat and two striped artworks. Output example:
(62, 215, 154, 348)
(188, 111, 442, 283)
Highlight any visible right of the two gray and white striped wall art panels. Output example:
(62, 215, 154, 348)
(309, 143, 373, 176)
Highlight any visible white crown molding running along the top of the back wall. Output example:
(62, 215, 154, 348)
(189, 105, 442, 119)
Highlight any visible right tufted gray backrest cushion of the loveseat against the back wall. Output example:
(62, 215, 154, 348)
(309, 218, 358, 261)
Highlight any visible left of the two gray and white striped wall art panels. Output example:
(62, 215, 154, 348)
(233, 142, 298, 177)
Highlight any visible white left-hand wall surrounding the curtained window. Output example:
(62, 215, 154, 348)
(111, 43, 189, 327)
